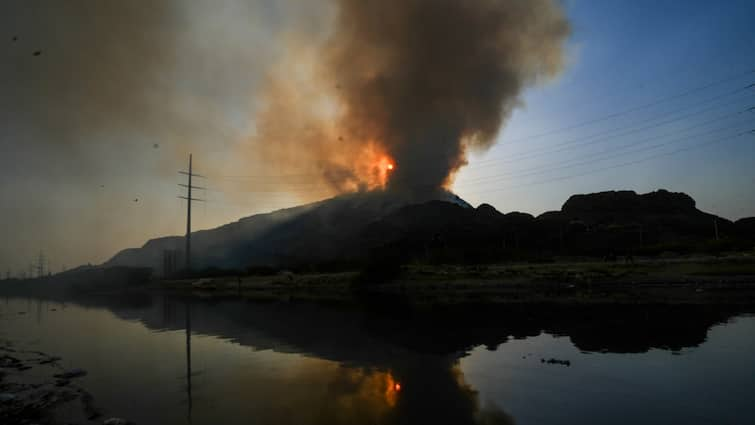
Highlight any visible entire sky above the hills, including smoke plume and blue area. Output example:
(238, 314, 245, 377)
(0, 0, 755, 274)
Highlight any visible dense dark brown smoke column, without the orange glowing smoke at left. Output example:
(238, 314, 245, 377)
(328, 0, 569, 188)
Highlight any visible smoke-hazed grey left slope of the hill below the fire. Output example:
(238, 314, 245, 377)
(105, 191, 471, 273)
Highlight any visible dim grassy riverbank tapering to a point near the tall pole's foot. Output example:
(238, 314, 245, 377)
(155, 255, 755, 305)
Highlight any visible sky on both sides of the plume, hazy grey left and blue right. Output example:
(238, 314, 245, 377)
(0, 0, 755, 274)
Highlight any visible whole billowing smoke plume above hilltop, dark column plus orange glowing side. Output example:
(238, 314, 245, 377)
(254, 0, 569, 192)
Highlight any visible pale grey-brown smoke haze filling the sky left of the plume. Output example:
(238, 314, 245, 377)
(0, 0, 322, 275)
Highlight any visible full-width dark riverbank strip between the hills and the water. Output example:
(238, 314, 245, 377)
(0, 252, 755, 306)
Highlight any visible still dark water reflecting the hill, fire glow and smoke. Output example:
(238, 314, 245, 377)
(0, 293, 755, 424)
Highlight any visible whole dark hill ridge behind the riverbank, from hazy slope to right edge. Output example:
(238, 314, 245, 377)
(107, 190, 755, 273)
